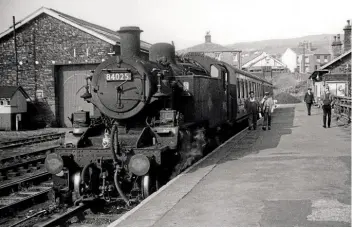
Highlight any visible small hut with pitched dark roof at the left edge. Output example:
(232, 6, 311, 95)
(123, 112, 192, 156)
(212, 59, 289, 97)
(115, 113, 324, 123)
(0, 86, 29, 131)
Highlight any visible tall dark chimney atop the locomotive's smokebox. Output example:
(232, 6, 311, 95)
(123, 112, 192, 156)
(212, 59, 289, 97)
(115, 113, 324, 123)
(117, 26, 143, 58)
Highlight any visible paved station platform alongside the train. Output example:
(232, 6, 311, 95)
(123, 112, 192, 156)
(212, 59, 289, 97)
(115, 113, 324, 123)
(110, 104, 351, 226)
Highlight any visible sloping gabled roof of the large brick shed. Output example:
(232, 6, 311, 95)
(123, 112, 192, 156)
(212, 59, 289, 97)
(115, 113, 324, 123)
(0, 7, 151, 51)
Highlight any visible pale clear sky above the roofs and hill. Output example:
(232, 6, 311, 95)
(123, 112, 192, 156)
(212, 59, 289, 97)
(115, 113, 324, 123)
(0, 0, 352, 50)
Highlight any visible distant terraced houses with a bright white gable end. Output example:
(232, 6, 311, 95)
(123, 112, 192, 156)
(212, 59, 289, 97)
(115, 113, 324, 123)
(281, 43, 331, 73)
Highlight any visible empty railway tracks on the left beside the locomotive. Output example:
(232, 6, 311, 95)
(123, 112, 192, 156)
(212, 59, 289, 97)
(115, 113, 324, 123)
(0, 133, 64, 224)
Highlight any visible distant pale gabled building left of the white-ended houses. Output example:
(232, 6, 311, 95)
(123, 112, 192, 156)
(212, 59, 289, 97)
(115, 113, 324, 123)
(242, 52, 287, 73)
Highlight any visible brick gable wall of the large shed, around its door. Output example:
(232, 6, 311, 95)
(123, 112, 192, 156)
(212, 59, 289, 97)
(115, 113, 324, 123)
(0, 14, 119, 126)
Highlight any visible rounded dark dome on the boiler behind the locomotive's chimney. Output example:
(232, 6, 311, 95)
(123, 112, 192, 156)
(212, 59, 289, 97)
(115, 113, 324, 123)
(149, 43, 176, 64)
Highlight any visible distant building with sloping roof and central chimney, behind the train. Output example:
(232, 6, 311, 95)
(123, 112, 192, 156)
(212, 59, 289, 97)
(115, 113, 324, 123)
(177, 32, 241, 67)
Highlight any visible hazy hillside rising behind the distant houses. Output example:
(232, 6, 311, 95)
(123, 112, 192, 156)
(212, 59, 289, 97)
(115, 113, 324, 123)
(226, 34, 343, 55)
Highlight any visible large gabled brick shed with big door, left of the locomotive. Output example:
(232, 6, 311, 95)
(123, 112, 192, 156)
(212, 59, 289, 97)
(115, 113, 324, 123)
(0, 7, 150, 127)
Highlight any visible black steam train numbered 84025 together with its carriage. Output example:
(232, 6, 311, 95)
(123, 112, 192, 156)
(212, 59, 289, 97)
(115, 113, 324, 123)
(45, 27, 272, 205)
